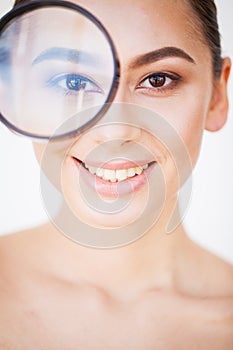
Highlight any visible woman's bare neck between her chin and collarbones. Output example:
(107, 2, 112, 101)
(35, 198, 188, 300)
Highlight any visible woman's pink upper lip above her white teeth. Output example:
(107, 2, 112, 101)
(73, 157, 156, 170)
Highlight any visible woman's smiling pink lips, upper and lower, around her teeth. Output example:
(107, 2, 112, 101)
(72, 157, 157, 198)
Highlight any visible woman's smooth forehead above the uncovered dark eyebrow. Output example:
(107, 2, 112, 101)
(56, 0, 204, 59)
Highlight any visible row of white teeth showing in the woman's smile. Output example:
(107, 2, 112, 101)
(84, 164, 149, 182)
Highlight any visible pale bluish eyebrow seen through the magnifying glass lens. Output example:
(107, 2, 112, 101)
(32, 47, 101, 66)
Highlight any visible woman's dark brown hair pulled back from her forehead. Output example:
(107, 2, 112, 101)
(14, 0, 222, 78)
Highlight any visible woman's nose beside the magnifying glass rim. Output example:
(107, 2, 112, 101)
(89, 81, 141, 143)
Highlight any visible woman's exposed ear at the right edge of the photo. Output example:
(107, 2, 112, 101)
(205, 57, 231, 131)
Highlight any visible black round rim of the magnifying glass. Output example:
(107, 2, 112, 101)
(0, 0, 120, 141)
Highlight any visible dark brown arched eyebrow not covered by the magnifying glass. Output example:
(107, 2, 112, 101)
(129, 46, 196, 69)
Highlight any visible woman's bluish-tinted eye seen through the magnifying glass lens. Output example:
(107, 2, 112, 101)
(47, 74, 103, 93)
